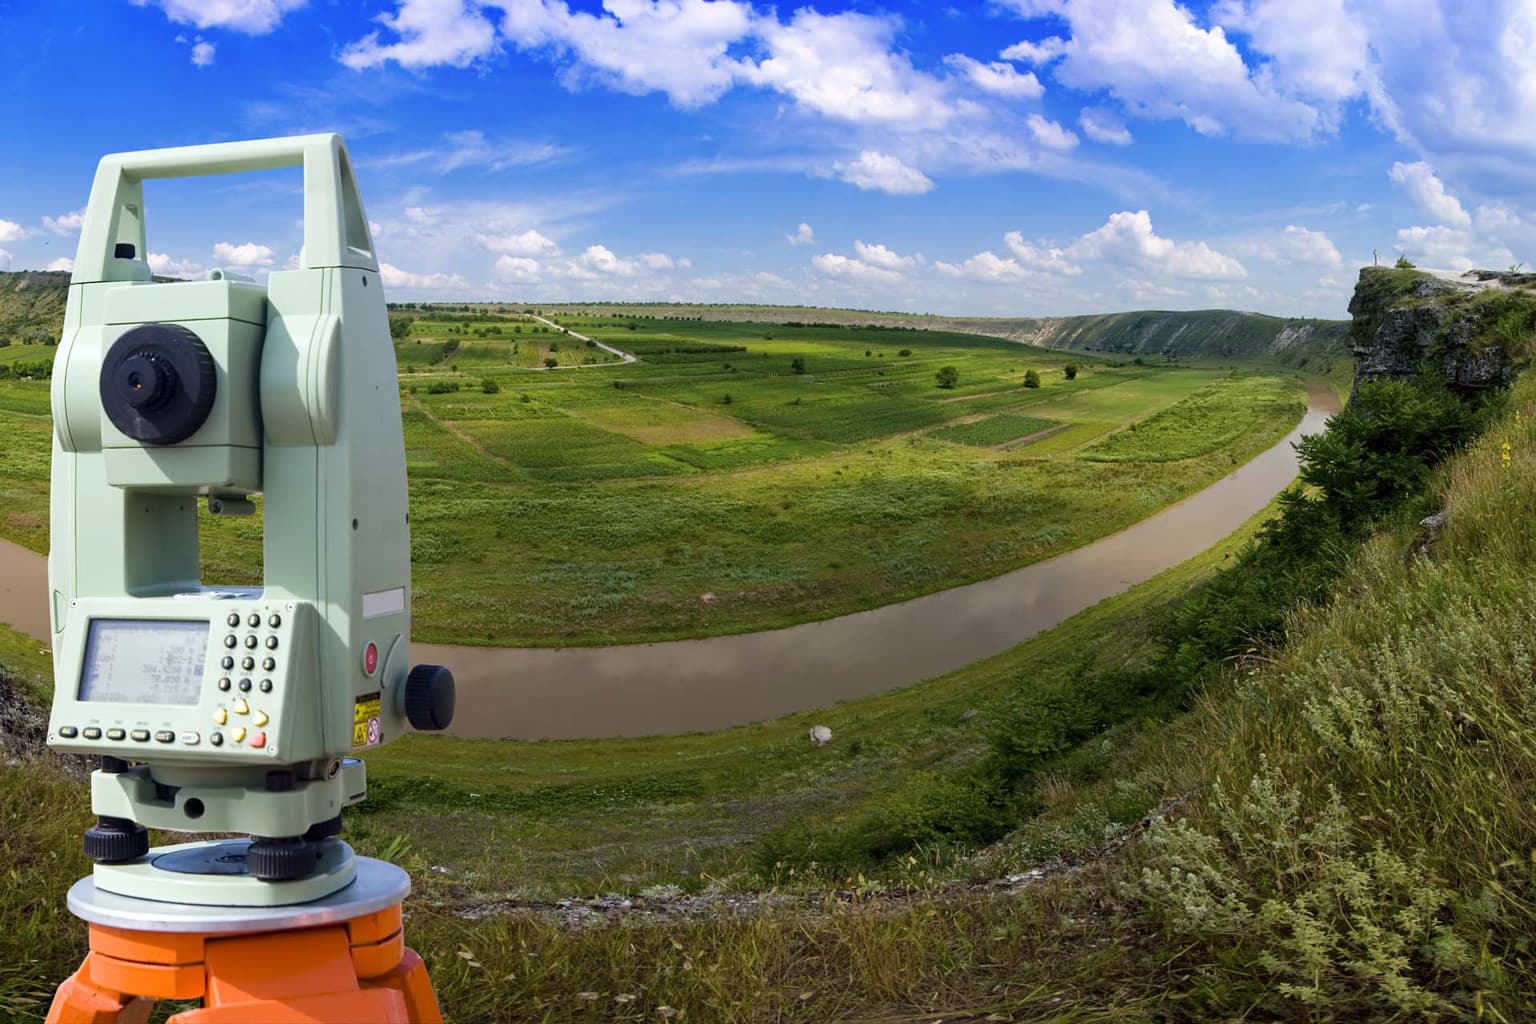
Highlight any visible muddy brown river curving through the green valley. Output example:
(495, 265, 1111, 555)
(0, 387, 1338, 740)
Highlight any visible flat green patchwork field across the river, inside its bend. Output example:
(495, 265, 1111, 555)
(0, 307, 1303, 645)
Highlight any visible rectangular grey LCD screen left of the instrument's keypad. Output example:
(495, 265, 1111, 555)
(80, 619, 209, 705)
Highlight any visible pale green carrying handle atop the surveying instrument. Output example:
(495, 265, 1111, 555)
(72, 132, 378, 284)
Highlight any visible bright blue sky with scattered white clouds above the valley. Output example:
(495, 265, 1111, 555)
(0, 0, 1536, 316)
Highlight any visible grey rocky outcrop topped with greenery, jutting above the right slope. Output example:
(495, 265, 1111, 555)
(1349, 267, 1536, 390)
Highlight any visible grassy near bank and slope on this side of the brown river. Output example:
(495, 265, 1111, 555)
(0, 369, 1536, 1024)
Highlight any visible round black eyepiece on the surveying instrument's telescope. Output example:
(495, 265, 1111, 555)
(100, 324, 218, 445)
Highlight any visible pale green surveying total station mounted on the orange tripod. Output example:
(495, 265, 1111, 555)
(48, 135, 453, 906)
